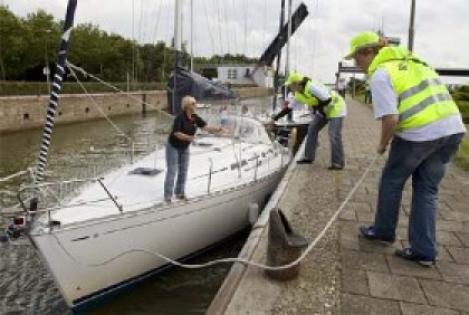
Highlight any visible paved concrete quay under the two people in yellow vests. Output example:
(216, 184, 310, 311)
(208, 99, 469, 315)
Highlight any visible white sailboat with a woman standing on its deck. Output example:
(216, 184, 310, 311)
(23, 117, 289, 308)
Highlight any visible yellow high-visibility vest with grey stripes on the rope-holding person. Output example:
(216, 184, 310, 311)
(368, 47, 460, 131)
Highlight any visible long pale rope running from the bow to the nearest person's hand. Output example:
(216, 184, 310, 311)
(52, 155, 379, 271)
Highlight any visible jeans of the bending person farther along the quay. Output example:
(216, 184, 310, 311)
(305, 114, 345, 167)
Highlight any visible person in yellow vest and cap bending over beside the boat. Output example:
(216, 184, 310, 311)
(273, 72, 346, 170)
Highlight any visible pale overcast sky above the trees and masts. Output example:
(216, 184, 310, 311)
(0, 0, 469, 83)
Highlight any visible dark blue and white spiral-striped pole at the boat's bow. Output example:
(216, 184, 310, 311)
(34, 0, 77, 184)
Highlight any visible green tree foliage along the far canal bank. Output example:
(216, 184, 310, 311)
(0, 5, 257, 82)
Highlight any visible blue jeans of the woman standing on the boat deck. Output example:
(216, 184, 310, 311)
(164, 143, 190, 199)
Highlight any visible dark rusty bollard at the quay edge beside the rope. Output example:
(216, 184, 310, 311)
(265, 209, 308, 281)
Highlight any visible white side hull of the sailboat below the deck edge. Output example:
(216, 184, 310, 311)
(31, 169, 283, 308)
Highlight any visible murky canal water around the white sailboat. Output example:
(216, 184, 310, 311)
(0, 98, 270, 314)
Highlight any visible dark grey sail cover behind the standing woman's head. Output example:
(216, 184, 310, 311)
(166, 67, 238, 115)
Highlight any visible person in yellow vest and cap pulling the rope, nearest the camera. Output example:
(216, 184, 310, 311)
(346, 32, 466, 266)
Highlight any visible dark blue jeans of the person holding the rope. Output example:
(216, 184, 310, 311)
(374, 134, 464, 258)
